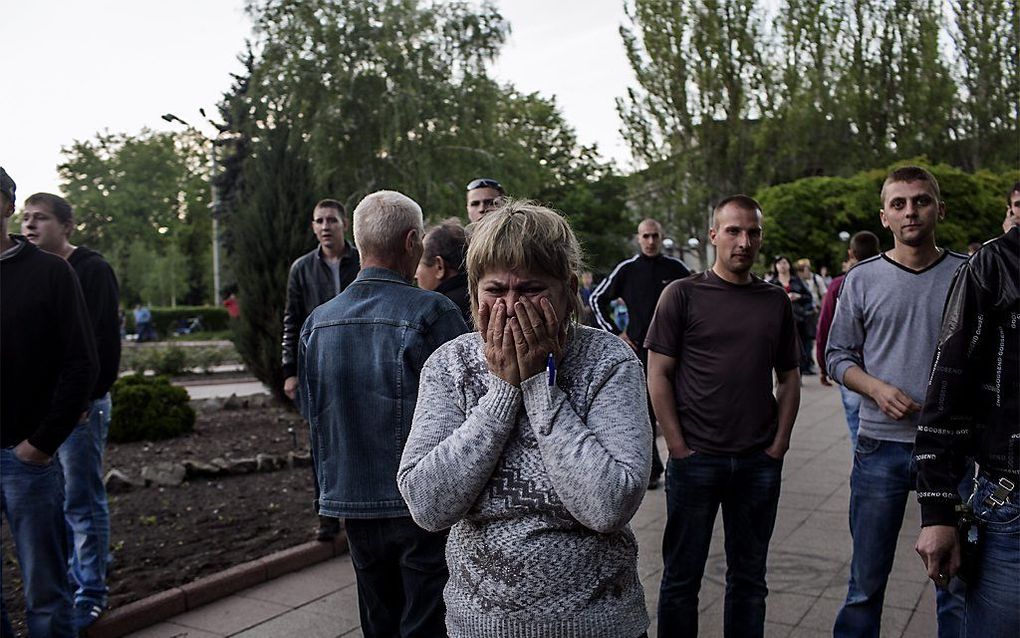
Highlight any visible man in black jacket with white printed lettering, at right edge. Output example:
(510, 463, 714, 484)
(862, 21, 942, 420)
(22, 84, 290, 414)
(914, 197, 1020, 637)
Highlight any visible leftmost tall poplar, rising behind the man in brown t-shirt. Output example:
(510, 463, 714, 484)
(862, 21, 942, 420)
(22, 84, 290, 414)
(617, 0, 768, 263)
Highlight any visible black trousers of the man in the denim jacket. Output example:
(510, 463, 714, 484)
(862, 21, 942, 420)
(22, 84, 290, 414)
(346, 517, 449, 638)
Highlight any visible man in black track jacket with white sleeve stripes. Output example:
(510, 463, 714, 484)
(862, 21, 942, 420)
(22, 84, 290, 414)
(589, 218, 691, 490)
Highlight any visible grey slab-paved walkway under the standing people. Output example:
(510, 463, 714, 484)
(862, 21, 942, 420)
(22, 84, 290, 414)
(125, 377, 935, 638)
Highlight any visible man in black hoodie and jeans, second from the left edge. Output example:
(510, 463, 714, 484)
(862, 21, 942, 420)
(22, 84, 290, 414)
(21, 193, 120, 630)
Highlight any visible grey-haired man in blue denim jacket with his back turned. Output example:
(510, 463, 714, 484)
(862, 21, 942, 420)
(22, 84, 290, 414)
(298, 191, 468, 638)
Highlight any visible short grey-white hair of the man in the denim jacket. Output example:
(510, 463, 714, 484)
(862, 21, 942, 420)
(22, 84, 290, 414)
(354, 191, 424, 258)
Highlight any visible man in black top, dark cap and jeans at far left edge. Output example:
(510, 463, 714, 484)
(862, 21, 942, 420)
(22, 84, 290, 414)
(0, 168, 99, 637)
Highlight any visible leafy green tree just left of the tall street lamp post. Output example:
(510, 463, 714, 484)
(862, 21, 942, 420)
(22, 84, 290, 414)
(57, 130, 212, 304)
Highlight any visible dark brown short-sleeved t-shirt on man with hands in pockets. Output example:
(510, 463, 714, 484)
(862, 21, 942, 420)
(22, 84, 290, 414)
(645, 271, 800, 455)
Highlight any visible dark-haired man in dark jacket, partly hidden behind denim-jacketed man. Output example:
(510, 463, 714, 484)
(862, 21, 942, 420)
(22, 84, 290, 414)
(282, 199, 361, 541)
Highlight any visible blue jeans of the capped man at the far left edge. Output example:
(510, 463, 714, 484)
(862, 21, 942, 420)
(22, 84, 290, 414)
(0, 448, 77, 638)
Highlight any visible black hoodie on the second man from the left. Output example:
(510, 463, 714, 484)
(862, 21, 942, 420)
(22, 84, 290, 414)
(67, 246, 120, 399)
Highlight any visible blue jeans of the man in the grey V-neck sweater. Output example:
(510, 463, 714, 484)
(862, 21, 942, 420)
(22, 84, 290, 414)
(832, 435, 970, 638)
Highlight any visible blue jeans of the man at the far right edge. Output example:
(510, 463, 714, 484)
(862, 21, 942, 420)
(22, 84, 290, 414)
(964, 476, 1020, 638)
